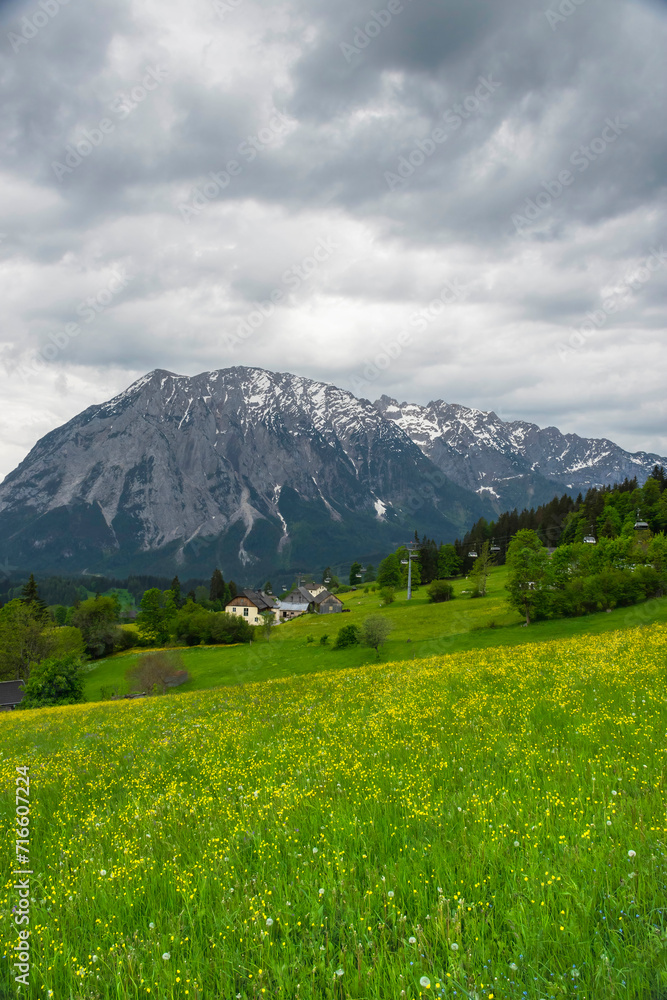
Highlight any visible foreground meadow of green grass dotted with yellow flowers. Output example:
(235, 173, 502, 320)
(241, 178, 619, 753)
(0, 625, 667, 1000)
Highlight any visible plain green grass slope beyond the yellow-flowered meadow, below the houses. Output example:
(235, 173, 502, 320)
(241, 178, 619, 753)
(86, 567, 667, 701)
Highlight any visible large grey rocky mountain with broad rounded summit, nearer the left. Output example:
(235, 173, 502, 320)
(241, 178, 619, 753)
(0, 367, 492, 583)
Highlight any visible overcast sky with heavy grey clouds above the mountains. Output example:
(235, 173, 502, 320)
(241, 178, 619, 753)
(0, 0, 667, 477)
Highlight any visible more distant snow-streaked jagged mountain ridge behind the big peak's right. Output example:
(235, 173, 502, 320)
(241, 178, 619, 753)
(374, 396, 667, 512)
